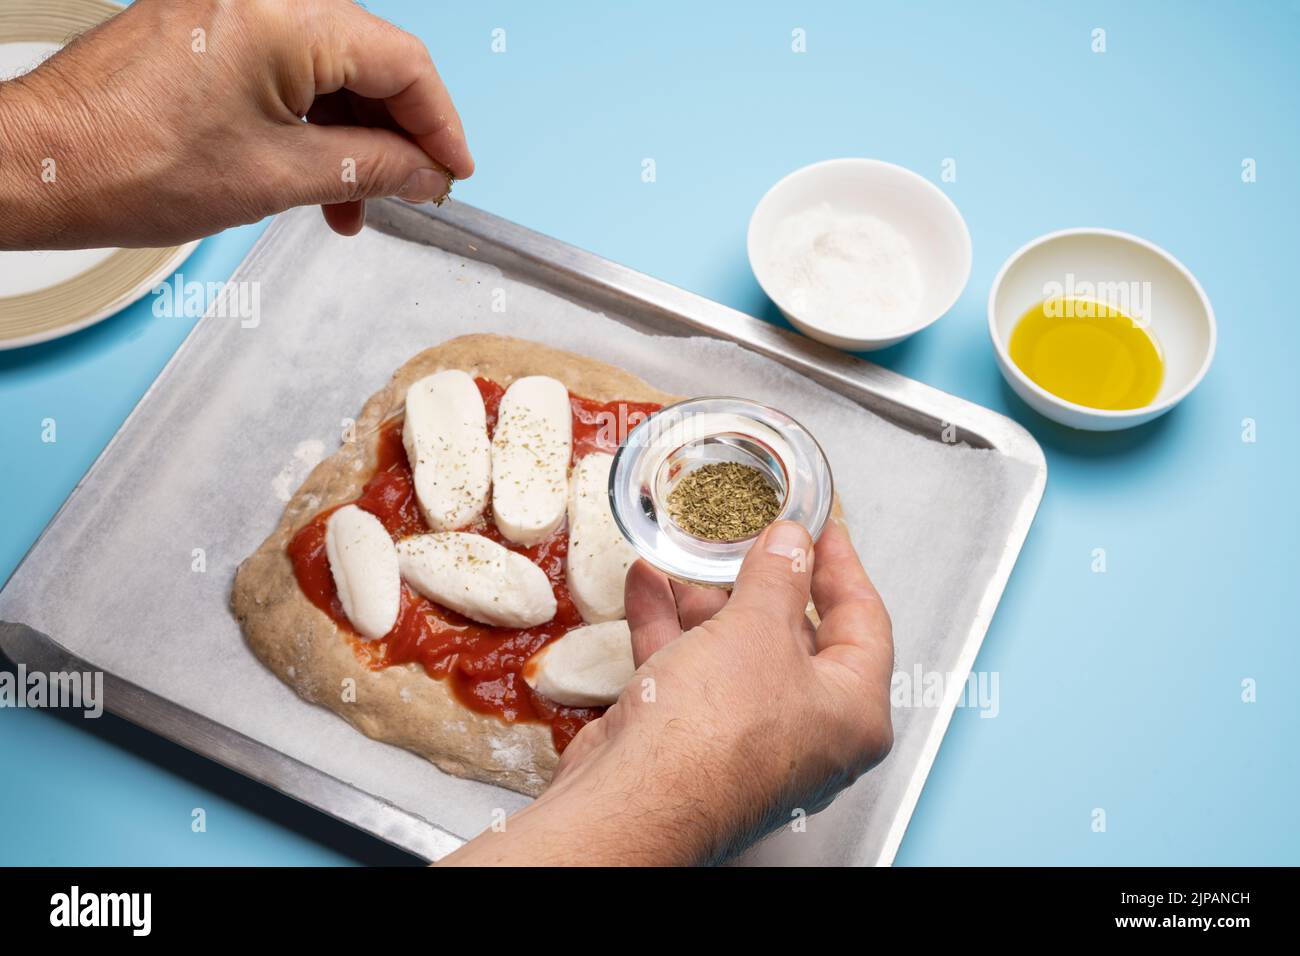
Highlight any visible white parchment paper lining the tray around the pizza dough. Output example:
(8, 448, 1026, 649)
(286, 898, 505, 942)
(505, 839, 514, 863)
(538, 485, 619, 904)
(0, 209, 1032, 864)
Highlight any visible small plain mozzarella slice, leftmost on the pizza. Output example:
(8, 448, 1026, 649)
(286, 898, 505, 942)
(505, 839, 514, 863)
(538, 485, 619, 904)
(325, 505, 402, 640)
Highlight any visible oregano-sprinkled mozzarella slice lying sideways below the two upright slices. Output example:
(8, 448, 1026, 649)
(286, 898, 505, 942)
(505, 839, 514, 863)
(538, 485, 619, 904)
(397, 531, 555, 627)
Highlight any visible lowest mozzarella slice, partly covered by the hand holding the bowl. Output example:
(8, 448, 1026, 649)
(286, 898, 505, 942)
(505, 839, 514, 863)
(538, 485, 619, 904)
(524, 620, 636, 708)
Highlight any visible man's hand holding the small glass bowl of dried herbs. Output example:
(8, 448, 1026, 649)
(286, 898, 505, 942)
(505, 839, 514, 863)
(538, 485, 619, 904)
(447, 522, 893, 864)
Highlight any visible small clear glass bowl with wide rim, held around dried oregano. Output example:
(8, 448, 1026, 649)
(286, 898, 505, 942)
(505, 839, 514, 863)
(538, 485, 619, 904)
(610, 398, 835, 588)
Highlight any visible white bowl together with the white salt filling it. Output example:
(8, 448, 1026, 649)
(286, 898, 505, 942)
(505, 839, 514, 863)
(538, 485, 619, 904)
(748, 159, 971, 351)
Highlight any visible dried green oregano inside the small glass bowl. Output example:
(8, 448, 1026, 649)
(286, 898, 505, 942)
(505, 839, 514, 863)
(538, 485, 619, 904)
(668, 462, 781, 541)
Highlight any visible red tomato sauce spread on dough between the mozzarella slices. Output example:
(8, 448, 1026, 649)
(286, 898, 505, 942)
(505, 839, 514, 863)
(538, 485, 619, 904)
(287, 378, 659, 752)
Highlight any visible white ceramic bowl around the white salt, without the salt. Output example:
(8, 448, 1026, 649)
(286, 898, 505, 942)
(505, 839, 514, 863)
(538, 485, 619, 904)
(746, 159, 971, 351)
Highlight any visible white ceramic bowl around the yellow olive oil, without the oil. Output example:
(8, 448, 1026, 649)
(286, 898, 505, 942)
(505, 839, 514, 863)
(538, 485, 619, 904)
(988, 229, 1217, 432)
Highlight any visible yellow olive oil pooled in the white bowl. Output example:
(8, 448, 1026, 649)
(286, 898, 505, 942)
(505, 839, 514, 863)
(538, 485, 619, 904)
(1010, 298, 1165, 411)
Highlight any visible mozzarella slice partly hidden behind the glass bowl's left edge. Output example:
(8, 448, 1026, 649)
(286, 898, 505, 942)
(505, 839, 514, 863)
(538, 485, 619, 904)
(568, 451, 637, 624)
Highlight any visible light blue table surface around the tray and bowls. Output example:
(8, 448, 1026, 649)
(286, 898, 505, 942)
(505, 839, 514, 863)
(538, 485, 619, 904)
(0, 0, 1300, 865)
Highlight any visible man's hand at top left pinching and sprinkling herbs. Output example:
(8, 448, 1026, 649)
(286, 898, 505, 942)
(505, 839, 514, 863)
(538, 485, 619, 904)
(0, 0, 473, 248)
